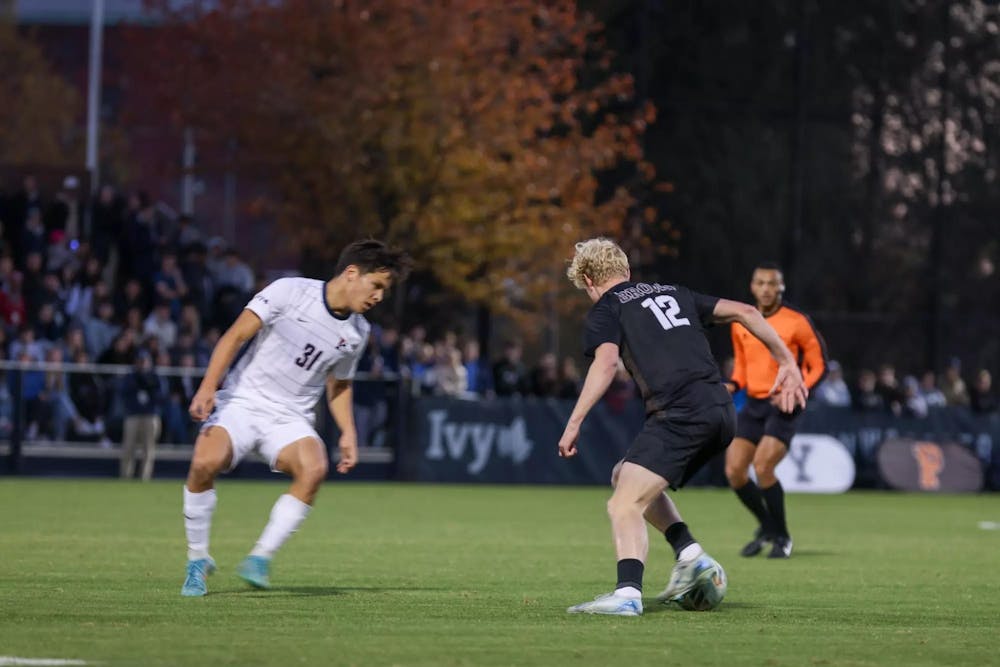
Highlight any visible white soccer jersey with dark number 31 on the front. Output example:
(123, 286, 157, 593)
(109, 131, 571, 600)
(219, 278, 371, 416)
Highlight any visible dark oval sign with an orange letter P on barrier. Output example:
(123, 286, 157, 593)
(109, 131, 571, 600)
(877, 438, 983, 493)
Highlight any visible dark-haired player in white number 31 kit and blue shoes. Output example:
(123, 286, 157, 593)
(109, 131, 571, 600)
(181, 240, 410, 596)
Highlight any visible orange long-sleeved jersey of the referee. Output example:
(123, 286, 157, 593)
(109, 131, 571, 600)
(731, 305, 826, 398)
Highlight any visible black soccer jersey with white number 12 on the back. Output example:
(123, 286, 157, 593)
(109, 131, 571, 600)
(584, 281, 732, 417)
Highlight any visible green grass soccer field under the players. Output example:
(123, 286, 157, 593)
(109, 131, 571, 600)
(0, 479, 1000, 667)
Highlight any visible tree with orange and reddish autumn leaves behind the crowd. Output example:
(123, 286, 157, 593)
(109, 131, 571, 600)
(141, 0, 654, 328)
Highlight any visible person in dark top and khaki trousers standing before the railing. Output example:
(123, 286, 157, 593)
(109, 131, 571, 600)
(120, 351, 161, 481)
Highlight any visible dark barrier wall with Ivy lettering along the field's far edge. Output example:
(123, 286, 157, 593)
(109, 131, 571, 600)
(397, 398, 1000, 491)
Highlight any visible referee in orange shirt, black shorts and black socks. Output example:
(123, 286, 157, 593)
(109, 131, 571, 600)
(726, 263, 826, 558)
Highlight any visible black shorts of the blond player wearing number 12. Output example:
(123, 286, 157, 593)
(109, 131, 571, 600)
(624, 403, 736, 489)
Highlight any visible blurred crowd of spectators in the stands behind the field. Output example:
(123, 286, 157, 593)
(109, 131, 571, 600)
(0, 176, 997, 445)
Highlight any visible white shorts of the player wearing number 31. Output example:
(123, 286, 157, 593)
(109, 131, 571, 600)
(201, 401, 323, 472)
